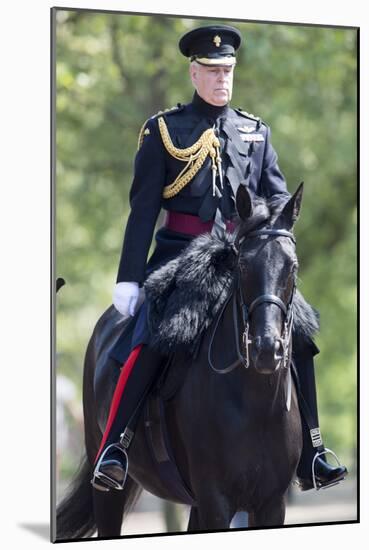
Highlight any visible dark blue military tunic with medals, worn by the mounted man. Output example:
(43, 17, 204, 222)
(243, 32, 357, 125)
(110, 93, 290, 363)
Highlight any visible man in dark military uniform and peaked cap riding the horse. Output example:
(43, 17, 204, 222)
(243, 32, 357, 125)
(92, 25, 347, 490)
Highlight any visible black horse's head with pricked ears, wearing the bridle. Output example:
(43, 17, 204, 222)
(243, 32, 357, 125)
(236, 184, 303, 374)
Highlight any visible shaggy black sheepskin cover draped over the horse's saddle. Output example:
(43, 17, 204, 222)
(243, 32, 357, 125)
(144, 233, 319, 354)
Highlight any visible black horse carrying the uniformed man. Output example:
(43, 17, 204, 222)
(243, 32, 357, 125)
(57, 185, 309, 540)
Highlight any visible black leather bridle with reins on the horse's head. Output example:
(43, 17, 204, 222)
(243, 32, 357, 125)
(208, 228, 296, 374)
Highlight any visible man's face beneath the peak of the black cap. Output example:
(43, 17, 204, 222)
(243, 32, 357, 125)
(190, 62, 234, 107)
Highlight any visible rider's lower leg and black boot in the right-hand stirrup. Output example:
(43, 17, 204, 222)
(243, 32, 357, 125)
(293, 338, 347, 491)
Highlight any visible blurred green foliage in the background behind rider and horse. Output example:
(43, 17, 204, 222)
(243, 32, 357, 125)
(56, 10, 357, 476)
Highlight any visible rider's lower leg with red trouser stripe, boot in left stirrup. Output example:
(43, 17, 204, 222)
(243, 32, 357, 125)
(91, 345, 165, 491)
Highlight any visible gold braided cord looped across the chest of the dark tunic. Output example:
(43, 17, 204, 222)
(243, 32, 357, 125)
(158, 117, 220, 199)
